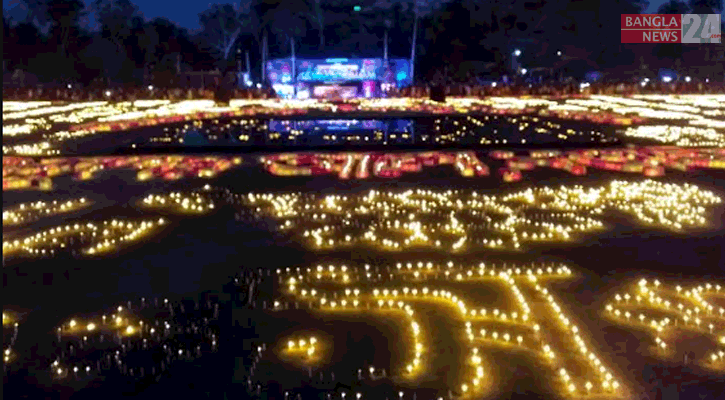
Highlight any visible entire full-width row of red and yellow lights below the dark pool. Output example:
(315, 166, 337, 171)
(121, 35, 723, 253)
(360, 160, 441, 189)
(3, 146, 725, 190)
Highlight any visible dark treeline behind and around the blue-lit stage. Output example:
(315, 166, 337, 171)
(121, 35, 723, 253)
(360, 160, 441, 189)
(3, 0, 725, 87)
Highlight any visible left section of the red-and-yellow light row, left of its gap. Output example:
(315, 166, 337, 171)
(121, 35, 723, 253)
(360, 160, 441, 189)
(3, 156, 242, 190)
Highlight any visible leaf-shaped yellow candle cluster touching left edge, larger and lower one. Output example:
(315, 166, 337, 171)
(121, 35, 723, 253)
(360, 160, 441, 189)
(3, 218, 166, 257)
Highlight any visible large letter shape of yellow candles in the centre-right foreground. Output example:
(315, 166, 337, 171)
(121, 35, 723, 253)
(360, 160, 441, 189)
(274, 263, 624, 393)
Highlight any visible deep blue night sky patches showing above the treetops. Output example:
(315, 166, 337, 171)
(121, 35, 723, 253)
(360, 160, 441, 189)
(3, 0, 720, 31)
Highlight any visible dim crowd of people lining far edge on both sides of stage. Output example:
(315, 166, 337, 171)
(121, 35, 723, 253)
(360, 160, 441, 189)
(3, 80, 725, 102)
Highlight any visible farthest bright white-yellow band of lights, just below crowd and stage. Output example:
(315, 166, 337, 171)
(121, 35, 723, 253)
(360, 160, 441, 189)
(3, 95, 725, 141)
